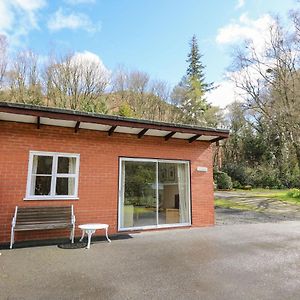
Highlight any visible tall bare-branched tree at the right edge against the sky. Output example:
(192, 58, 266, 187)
(232, 20, 300, 167)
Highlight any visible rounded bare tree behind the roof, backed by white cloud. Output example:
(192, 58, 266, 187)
(44, 54, 109, 113)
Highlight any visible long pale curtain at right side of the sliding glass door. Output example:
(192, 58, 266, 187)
(177, 164, 189, 223)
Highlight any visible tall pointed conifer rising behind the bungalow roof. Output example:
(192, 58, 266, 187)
(172, 35, 212, 124)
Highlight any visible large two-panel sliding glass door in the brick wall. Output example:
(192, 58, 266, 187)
(119, 158, 190, 230)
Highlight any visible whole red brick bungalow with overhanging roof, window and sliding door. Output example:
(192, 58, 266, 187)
(0, 102, 229, 243)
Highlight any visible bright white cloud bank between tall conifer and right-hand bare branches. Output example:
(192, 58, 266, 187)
(213, 14, 284, 108)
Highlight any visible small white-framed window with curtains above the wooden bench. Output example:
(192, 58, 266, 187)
(25, 151, 79, 200)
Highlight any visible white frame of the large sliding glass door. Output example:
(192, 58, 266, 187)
(118, 157, 192, 231)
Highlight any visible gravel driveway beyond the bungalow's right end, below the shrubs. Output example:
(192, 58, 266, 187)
(215, 191, 300, 225)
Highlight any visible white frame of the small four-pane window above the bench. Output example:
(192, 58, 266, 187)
(23, 151, 80, 200)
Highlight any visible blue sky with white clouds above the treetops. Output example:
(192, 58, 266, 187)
(0, 0, 299, 107)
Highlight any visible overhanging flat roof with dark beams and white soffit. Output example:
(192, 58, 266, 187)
(0, 102, 229, 143)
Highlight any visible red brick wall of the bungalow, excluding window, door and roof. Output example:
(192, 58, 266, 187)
(0, 121, 214, 243)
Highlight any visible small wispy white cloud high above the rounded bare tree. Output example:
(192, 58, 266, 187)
(48, 8, 100, 32)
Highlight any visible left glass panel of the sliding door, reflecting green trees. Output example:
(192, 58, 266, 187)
(121, 161, 157, 228)
